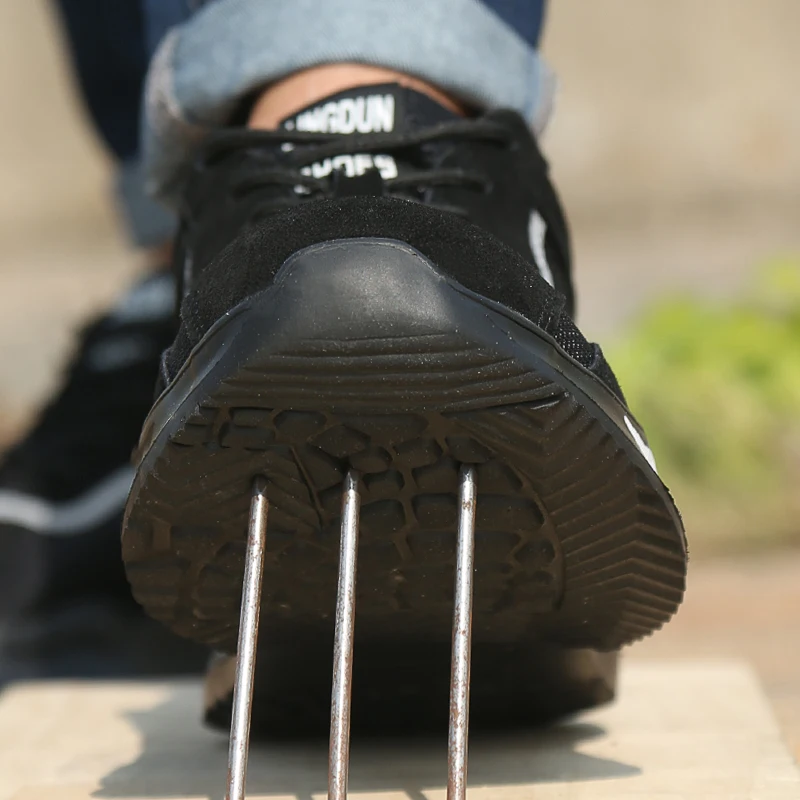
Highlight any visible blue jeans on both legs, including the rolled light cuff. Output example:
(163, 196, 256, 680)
(58, 0, 553, 220)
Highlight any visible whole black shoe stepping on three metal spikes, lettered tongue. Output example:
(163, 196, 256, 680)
(123, 85, 686, 730)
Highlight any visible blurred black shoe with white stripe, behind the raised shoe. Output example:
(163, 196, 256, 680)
(0, 273, 205, 687)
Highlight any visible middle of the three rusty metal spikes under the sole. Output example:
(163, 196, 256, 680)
(328, 472, 361, 800)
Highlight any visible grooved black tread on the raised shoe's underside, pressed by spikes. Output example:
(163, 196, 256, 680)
(124, 336, 685, 649)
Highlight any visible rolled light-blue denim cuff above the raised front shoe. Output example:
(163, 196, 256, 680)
(142, 0, 554, 202)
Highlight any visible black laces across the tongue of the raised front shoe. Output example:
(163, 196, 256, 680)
(195, 120, 511, 218)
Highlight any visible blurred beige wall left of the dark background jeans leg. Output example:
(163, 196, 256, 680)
(0, 0, 119, 248)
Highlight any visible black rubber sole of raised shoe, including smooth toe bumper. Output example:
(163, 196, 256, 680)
(123, 234, 687, 716)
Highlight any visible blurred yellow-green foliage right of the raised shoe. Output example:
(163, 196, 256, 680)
(609, 260, 800, 554)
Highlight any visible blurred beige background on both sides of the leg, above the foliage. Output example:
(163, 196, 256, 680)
(0, 0, 800, 430)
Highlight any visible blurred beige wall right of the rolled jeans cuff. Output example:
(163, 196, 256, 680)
(545, 0, 800, 222)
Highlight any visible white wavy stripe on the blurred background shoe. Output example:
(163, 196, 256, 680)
(0, 466, 134, 536)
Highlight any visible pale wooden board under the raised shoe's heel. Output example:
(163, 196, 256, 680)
(0, 661, 800, 800)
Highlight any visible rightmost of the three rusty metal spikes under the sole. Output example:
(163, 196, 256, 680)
(447, 466, 477, 800)
